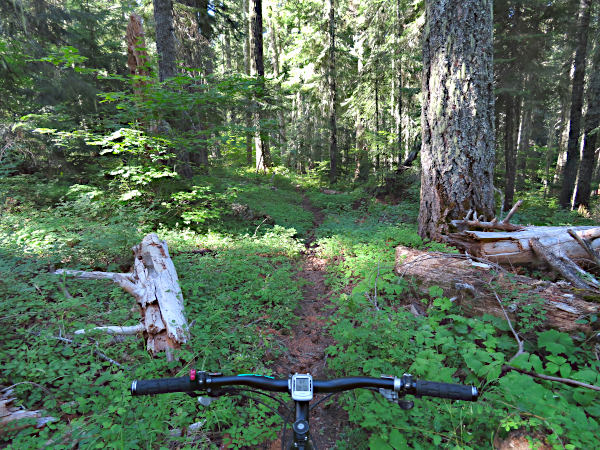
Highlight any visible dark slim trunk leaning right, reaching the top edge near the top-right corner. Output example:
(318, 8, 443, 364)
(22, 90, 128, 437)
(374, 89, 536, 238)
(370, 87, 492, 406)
(560, 0, 592, 209)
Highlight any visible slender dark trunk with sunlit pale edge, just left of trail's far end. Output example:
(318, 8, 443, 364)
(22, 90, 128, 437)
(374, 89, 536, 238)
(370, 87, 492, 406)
(249, 0, 271, 172)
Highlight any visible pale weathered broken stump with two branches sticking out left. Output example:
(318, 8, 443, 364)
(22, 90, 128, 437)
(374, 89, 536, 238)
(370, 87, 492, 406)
(54, 233, 188, 361)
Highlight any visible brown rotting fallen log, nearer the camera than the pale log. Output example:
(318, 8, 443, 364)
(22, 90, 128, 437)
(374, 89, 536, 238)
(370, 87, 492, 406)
(396, 246, 600, 332)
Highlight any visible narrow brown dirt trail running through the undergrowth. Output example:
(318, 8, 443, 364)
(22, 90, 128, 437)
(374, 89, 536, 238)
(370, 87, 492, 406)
(264, 194, 348, 450)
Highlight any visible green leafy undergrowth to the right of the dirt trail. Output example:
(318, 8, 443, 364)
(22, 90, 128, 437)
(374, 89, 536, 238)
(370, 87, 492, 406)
(308, 195, 600, 450)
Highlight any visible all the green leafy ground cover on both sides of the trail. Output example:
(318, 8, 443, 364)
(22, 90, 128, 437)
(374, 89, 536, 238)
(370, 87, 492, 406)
(0, 168, 600, 450)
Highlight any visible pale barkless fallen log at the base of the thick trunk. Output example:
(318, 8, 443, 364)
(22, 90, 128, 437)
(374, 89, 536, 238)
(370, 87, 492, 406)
(446, 226, 600, 267)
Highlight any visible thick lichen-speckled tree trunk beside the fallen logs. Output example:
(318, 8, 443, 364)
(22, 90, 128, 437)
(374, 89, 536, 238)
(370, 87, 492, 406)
(419, 0, 495, 240)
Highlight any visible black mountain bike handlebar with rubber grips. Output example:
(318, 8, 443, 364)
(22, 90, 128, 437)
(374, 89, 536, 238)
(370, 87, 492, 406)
(131, 369, 479, 401)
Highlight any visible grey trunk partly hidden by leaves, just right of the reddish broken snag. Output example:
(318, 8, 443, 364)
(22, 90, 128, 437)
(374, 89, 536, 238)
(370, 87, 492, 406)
(154, 0, 193, 178)
